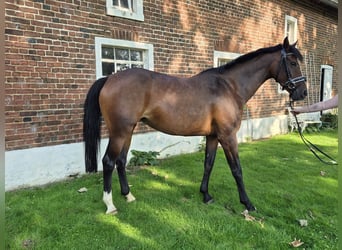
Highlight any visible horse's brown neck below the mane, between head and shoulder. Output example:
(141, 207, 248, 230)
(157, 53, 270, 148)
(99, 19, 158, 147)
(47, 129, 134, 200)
(227, 54, 274, 103)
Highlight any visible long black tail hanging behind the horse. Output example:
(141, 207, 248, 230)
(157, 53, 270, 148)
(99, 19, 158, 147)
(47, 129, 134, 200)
(83, 77, 108, 172)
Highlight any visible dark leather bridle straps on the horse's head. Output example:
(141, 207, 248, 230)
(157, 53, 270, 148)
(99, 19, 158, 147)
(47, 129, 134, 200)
(276, 48, 306, 93)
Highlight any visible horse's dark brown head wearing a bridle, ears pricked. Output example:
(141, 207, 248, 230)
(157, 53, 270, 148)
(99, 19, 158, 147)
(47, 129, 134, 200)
(275, 37, 308, 101)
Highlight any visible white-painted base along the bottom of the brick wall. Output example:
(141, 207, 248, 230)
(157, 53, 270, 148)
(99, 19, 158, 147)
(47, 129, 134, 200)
(5, 115, 288, 191)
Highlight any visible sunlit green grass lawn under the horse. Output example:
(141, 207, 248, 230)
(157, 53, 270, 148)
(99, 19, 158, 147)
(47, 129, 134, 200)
(5, 130, 338, 250)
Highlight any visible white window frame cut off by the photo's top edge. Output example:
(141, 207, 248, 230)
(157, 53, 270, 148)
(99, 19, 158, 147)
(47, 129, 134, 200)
(106, 0, 144, 21)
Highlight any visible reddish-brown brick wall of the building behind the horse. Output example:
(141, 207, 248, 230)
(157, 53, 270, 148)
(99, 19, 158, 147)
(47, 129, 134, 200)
(5, 0, 337, 150)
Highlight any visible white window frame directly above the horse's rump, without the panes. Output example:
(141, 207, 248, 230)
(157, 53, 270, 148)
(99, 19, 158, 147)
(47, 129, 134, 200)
(95, 37, 154, 79)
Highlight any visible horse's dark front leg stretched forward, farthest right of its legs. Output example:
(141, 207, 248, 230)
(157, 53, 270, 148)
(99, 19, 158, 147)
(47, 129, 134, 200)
(220, 135, 256, 211)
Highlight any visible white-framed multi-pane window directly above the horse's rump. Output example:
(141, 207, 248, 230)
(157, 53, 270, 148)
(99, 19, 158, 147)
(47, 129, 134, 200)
(95, 37, 153, 78)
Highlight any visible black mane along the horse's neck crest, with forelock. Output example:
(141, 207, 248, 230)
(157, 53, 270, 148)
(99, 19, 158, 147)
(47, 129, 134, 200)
(201, 44, 303, 74)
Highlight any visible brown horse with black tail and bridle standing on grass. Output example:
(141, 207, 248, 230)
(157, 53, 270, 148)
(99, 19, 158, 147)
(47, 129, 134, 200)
(83, 38, 307, 214)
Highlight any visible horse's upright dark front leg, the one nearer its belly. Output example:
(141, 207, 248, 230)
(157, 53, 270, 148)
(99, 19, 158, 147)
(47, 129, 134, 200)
(200, 136, 218, 203)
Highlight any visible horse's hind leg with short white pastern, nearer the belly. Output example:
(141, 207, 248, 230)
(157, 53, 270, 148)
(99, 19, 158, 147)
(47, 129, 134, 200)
(116, 138, 135, 202)
